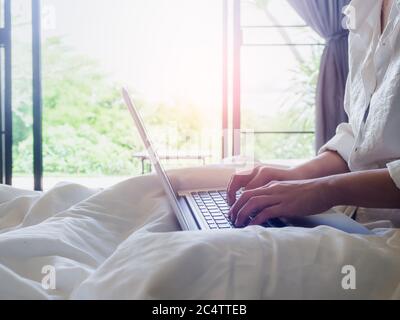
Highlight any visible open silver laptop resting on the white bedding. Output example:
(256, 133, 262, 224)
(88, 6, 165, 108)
(122, 88, 373, 234)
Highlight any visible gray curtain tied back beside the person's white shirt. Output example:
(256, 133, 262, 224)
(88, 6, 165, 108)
(288, 0, 350, 150)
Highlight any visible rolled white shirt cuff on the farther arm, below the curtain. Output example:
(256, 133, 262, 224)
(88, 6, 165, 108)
(318, 123, 355, 162)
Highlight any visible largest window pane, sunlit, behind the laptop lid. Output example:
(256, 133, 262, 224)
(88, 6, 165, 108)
(42, 0, 222, 188)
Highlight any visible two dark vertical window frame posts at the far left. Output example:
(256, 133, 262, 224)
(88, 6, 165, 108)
(0, 0, 43, 191)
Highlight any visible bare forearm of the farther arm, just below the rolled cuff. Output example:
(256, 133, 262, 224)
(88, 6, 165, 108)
(291, 151, 349, 180)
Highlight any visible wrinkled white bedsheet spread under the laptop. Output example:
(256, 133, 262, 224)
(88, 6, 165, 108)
(0, 168, 400, 299)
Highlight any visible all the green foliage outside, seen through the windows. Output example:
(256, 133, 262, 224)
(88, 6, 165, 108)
(13, 0, 321, 175)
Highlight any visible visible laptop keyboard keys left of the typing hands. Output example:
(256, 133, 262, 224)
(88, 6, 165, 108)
(191, 191, 238, 229)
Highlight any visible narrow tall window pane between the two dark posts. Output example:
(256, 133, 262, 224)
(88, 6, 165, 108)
(11, 0, 33, 189)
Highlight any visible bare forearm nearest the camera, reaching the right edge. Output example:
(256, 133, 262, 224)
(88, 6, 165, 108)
(324, 169, 400, 208)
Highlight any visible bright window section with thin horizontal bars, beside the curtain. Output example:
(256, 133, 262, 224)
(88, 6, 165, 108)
(241, 0, 324, 160)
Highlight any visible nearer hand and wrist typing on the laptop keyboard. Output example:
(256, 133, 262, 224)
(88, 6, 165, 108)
(230, 179, 333, 227)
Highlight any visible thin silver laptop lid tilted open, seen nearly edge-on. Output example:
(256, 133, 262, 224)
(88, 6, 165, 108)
(122, 88, 189, 230)
